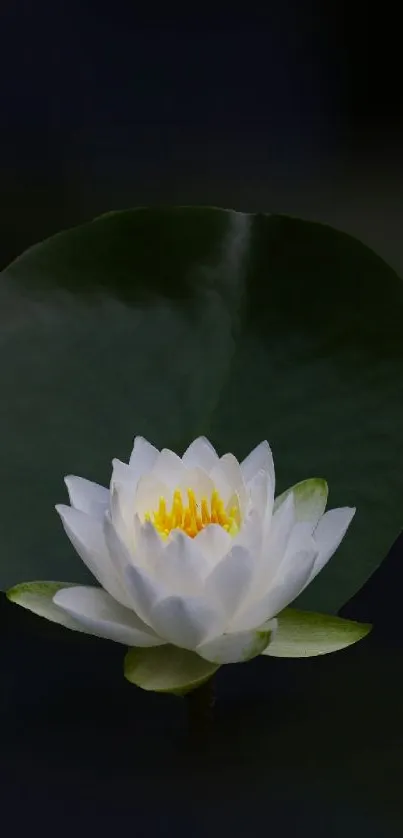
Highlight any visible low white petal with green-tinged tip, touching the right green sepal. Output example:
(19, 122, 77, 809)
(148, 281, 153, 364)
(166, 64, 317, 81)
(196, 620, 277, 664)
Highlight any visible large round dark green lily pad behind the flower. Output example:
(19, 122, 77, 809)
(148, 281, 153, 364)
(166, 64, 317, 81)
(0, 208, 403, 611)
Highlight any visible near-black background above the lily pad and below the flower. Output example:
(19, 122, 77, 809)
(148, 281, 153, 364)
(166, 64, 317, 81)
(0, 0, 403, 838)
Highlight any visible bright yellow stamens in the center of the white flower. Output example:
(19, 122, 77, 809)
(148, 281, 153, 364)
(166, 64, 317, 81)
(144, 489, 241, 538)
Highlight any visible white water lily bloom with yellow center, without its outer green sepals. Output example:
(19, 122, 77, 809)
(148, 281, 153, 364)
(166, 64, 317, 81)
(23, 437, 355, 664)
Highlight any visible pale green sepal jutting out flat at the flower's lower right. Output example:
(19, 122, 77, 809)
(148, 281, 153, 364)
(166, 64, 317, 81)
(262, 608, 372, 658)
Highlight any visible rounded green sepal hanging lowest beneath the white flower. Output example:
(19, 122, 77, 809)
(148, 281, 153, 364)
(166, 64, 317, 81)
(124, 645, 219, 695)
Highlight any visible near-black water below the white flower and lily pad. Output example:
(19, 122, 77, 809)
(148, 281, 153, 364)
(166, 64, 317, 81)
(0, 538, 403, 838)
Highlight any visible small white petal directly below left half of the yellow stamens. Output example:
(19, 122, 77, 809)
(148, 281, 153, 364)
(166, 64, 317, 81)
(155, 530, 208, 596)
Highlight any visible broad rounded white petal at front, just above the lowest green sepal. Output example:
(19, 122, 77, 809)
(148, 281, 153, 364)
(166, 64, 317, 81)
(150, 596, 224, 650)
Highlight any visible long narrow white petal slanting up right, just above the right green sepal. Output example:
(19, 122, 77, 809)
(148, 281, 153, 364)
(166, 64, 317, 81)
(231, 549, 317, 631)
